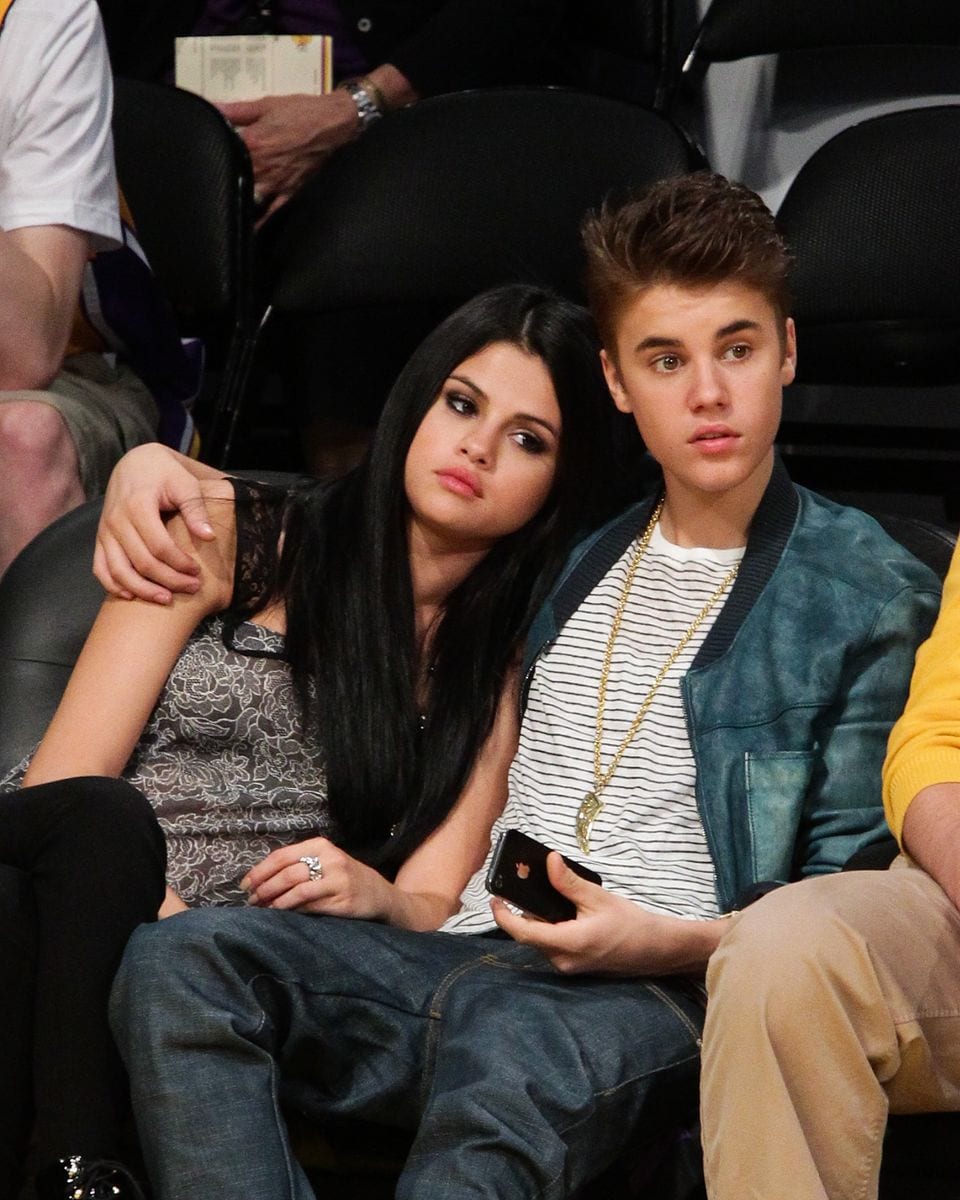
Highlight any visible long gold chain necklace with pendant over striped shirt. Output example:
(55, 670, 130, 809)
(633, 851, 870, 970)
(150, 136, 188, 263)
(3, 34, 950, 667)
(576, 500, 740, 854)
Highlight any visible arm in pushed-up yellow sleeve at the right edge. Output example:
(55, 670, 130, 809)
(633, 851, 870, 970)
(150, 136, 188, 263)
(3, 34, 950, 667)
(883, 540, 960, 907)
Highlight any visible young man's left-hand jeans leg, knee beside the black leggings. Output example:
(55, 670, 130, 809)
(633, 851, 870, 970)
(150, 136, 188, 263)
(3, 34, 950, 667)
(112, 908, 525, 1200)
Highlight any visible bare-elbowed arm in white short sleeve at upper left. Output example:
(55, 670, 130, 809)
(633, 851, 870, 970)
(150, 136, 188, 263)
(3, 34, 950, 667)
(0, 0, 120, 390)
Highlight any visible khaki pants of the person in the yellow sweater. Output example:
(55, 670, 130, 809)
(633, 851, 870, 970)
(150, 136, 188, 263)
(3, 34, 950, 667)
(701, 857, 960, 1200)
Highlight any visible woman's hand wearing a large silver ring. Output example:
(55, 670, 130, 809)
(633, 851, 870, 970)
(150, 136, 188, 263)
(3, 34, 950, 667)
(240, 838, 397, 920)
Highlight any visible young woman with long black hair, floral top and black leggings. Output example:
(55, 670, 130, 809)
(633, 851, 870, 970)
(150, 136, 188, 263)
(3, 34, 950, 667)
(0, 286, 624, 1200)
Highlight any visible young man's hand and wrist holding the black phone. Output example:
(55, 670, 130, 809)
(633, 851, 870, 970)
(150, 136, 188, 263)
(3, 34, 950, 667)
(491, 851, 726, 976)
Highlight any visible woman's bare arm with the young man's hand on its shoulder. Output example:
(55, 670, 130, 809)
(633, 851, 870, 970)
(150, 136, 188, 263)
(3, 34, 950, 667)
(24, 481, 235, 786)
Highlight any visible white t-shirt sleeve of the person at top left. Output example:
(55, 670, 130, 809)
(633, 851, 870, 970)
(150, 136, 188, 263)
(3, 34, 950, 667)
(0, 0, 121, 250)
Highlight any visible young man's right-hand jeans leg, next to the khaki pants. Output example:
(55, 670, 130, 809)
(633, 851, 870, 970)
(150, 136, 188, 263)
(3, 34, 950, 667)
(397, 955, 703, 1200)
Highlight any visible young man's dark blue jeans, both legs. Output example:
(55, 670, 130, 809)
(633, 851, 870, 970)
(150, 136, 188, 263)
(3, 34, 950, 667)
(112, 908, 703, 1200)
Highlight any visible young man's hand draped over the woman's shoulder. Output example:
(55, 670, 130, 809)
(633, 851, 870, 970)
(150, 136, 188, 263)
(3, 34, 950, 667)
(94, 444, 223, 604)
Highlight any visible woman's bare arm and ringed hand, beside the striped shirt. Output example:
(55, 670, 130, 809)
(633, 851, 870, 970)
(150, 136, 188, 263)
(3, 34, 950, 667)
(244, 679, 520, 930)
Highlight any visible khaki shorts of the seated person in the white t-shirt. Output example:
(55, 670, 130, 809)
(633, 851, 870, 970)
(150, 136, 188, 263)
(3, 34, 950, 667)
(0, 354, 157, 499)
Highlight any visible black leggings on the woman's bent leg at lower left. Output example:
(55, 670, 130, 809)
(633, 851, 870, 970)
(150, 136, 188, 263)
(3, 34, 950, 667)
(0, 778, 167, 1200)
